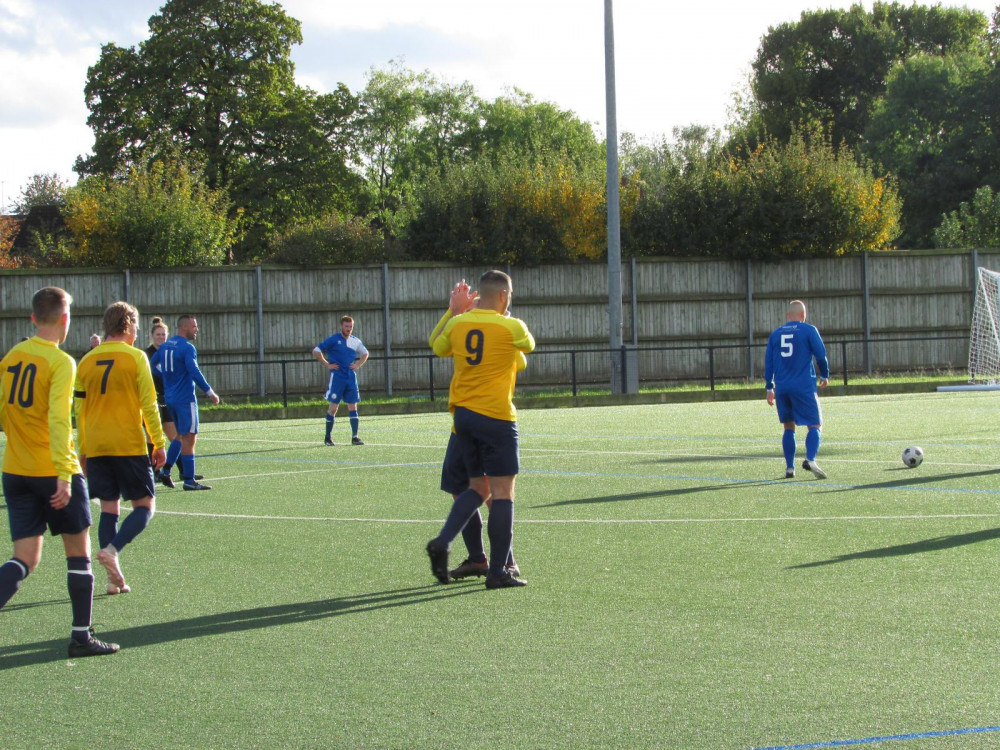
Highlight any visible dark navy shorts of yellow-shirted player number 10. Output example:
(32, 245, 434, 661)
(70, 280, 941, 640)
(3, 473, 90, 541)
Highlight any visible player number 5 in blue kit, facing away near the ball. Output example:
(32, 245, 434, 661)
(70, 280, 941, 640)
(764, 300, 830, 479)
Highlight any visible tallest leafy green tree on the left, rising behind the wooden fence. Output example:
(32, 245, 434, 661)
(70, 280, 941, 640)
(76, 0, 356, 258)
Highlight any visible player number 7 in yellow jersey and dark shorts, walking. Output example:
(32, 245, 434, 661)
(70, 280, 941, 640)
(75, 302, 166, 594)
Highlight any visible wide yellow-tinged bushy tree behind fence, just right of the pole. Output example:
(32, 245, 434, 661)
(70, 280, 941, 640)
(622, 131, 900, 260)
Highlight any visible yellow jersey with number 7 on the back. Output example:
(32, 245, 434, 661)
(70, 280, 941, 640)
(75, 341, 164, 456)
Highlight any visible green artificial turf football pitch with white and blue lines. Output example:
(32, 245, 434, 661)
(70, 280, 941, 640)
(0, 393, 1000, 750)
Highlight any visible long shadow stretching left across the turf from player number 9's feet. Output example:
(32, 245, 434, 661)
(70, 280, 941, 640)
(0, 584, 485, 671)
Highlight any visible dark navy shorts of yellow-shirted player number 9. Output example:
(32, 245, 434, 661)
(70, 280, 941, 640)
(441, 406, 521, 482)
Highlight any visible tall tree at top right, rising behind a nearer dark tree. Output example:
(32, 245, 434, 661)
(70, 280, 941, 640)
(744, 2, 987, 148)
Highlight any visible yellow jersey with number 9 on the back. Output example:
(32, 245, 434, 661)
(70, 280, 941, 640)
(430, 308, 535, 422)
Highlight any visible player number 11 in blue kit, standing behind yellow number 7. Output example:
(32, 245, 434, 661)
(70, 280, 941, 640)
(150, 315, 219, 490)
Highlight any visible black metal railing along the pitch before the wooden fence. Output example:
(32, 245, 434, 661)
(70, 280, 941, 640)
(191, 336, 968, 408)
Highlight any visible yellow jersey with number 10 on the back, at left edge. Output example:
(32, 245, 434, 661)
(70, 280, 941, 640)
(0, 336, 80, 481)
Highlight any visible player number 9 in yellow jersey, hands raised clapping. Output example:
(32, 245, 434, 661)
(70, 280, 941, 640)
(427, 271, 535, 589)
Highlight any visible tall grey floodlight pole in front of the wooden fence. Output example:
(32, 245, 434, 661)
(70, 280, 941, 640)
(604, 0, 625, 393)
